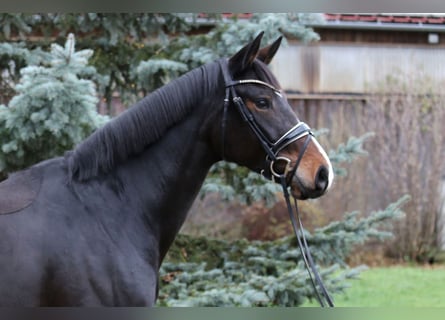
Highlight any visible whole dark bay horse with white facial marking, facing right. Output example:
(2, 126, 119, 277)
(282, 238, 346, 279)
(0, 34, 333, 306)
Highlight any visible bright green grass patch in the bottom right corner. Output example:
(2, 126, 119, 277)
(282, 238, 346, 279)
(304, 266, 445, 307)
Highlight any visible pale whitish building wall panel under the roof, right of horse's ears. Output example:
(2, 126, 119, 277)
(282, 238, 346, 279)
(271, 42, 445, 94)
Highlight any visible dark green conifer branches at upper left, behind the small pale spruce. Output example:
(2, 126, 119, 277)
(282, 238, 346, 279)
(0, 13, 196, 110)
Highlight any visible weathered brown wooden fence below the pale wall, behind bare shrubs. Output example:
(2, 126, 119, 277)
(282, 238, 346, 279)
(289, 95, 445, 252)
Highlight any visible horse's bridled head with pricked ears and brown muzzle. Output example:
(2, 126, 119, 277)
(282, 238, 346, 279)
(220, 33, 334, 199)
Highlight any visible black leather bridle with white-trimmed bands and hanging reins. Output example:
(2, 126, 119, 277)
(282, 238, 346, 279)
(218, 59, 334, 307)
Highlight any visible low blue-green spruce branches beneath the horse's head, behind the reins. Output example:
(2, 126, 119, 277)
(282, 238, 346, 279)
(158, 196, 409, 307)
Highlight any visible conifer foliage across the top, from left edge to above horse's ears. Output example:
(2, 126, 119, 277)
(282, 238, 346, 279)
(0, 13, 321, 111)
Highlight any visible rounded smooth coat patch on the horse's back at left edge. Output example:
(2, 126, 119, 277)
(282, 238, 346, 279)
(0, 167, 42, 214)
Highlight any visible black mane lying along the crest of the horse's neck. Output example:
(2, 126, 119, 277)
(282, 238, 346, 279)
(66, 63, 219, 181)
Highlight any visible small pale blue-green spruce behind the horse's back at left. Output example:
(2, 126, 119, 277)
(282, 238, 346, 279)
(0, 34, 107, 172)
